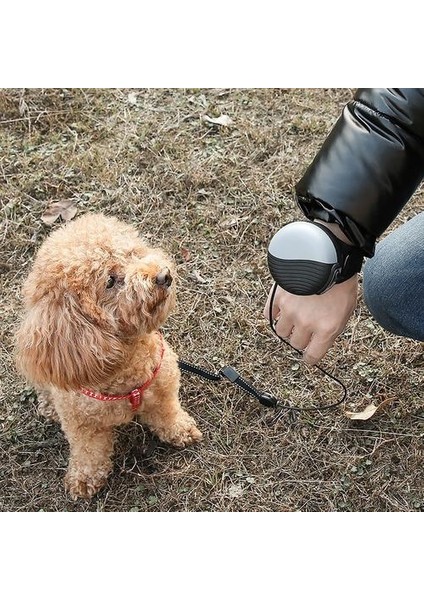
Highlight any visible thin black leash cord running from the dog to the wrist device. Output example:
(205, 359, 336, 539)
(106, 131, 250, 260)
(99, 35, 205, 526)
(178, 283, 347, 418)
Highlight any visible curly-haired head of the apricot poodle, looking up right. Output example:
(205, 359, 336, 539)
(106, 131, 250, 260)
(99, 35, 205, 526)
(16, 214, 175, 389)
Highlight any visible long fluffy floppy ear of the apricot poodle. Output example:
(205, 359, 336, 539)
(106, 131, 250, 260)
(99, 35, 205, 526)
(15, 293, 123, 390)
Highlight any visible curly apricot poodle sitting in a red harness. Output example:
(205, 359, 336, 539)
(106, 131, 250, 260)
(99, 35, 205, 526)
(16, 214, 202, 498)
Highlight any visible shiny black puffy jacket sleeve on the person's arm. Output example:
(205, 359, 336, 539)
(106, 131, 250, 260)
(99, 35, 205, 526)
(296, 88, 424, 256)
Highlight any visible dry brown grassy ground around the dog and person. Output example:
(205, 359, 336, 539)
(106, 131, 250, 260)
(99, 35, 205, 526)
(0, 89, 424, 511)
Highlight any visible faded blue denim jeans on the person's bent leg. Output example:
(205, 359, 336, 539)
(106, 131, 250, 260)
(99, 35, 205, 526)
(363, 212, 424, 341)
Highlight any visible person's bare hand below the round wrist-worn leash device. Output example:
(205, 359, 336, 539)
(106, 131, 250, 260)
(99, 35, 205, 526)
(264, 275, 358, 365)
